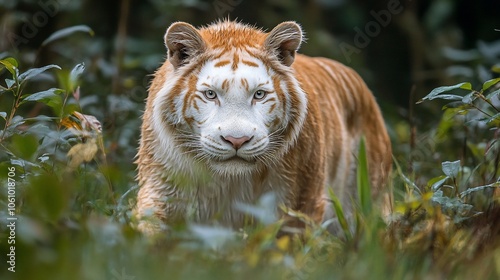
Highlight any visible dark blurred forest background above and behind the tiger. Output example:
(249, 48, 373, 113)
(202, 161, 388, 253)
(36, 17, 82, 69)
(0, 0, 500, 104)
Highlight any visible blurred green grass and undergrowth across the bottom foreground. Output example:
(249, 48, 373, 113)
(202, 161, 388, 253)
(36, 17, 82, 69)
(0, 132, 500, 279)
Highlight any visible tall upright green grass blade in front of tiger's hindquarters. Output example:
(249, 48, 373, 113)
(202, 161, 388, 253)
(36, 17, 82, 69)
(357, 137, 372, 216)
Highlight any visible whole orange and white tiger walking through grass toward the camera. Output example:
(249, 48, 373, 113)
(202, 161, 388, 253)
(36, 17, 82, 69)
(134, 20, 392, 234)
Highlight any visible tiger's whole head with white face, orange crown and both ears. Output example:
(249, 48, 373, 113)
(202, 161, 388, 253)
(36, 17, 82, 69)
(153, 21, 307, 175)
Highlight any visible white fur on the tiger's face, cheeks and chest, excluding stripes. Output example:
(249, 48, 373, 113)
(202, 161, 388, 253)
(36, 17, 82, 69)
(146, 50, 307, 225)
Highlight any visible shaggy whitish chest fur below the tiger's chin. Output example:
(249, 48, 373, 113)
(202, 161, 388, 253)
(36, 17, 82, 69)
(177, 165, 290, 228)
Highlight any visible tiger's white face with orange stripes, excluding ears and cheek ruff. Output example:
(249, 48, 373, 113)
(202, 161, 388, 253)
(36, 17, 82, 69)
(185, 55, 286, 173)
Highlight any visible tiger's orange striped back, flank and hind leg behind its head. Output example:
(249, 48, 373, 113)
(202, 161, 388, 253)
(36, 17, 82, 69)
(293, 55, 392, 225)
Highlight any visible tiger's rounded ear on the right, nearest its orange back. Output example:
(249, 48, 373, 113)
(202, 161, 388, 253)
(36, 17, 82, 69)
(264, 21, 303, 66)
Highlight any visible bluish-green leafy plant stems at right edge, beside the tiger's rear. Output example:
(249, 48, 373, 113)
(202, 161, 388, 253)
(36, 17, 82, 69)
(421, 75, 500, 202)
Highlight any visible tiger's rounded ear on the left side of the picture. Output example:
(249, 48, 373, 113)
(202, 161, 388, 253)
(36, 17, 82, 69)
(165, 22, 206, 68)
